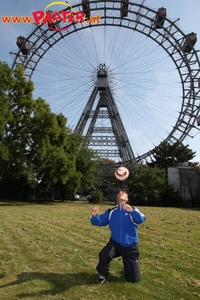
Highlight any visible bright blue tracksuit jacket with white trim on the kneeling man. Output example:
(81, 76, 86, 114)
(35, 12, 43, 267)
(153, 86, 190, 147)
(90, 206, 146, 247)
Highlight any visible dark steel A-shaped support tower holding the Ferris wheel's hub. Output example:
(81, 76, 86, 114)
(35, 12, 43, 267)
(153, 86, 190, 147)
(75, 64, 137, 169)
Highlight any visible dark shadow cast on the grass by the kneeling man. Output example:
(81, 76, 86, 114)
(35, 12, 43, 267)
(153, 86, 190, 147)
(0, 272, 121, 298)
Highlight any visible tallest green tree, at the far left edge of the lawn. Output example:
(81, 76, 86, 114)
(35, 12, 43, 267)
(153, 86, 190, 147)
(0, 63, 34, 179)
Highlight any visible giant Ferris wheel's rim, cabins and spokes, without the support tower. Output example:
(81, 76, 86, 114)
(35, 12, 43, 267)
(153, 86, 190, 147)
(11, 0, 200, 161)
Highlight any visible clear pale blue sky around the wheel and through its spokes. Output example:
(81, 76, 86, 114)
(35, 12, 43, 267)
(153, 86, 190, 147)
(0, 0, 200, 162)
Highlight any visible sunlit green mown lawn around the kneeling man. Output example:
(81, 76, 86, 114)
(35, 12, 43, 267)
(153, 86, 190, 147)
(0, 202, 200, 300)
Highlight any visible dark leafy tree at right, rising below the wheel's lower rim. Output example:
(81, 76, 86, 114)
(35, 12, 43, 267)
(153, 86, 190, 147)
(148, 142, 196, 169)
